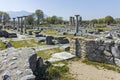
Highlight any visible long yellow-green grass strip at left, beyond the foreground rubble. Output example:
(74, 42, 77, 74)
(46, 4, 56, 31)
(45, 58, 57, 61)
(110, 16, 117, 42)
(10, 39, 45, 48)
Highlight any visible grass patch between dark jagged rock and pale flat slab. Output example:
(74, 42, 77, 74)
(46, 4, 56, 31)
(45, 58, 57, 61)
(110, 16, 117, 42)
(37, 48, 62, 59)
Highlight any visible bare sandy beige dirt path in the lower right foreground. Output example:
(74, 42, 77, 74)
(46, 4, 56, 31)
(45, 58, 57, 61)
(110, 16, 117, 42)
(69, 61, 120, 80)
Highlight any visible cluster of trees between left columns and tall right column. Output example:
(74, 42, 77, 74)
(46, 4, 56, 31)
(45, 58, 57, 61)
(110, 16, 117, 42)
(27, 9, 65, 25)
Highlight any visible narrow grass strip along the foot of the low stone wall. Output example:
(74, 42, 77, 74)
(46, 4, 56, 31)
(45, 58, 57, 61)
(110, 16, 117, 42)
(82, 59, 120, 73)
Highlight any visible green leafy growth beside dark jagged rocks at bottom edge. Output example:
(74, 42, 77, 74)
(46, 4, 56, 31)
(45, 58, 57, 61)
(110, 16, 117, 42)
(47, 65, 74, 80)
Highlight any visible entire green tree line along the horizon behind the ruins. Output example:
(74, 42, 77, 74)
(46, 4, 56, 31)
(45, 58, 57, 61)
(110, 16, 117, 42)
(0, 9, 120, 25)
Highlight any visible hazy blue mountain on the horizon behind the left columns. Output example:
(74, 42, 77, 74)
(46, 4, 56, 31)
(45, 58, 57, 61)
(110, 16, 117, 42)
(8, 11, 32, 18)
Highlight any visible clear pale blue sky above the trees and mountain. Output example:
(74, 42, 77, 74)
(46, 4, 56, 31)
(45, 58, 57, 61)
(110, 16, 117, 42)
(0, 0, 120, 19)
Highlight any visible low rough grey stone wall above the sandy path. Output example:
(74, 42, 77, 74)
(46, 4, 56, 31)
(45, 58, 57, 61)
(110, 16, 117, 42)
(70, 39, 120, 66)
